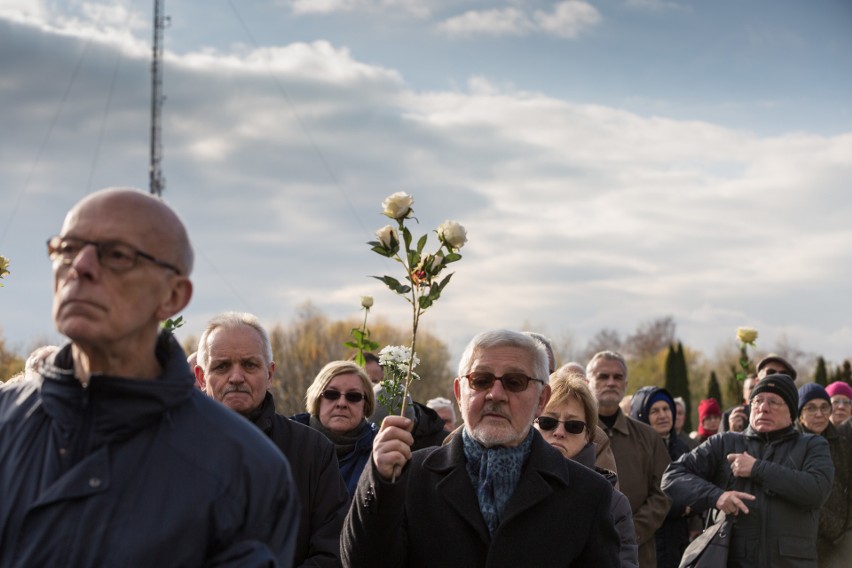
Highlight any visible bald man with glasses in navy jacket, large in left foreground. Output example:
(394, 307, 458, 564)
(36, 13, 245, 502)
(0, 189, 299, 567)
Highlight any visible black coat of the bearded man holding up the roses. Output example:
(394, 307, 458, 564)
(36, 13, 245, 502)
(341, 432, 619, 568)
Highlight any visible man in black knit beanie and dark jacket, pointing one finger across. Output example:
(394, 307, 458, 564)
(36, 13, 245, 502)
(663, 374, 834, 568)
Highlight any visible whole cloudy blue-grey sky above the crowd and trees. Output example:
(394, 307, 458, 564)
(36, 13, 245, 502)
(0, 0, 852, 368)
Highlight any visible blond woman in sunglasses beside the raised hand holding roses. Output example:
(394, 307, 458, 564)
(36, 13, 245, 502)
(293, 361, 378, 495)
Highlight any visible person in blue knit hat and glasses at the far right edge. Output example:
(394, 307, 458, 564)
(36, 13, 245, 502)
(796, 383, 852, 567)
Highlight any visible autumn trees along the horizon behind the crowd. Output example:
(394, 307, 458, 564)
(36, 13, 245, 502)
(0, 316, 852, 427)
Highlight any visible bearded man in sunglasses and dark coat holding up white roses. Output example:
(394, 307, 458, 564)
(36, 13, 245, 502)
(341, 330, 619, 568)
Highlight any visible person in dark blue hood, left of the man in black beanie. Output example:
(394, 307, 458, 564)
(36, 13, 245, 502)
(630, 387, 692, 568)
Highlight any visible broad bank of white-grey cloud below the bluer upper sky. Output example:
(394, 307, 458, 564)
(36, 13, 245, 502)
(5, 14, 852, 368)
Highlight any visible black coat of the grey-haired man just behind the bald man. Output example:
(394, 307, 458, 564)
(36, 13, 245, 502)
(251, 392, 349, 567)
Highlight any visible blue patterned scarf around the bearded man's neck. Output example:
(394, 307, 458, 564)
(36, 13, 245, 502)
(462, 428, 533, 536)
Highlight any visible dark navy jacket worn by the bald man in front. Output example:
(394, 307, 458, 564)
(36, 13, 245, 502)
(0, 333, 299, 568)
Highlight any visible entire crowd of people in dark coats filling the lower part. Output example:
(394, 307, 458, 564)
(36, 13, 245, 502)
(0, 189, 852, 568)
